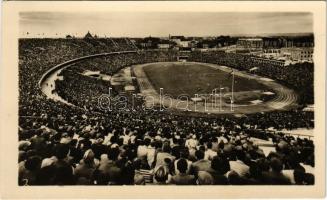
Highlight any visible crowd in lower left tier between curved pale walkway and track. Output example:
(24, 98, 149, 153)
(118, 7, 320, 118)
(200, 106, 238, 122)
(56, 51, 176, 110)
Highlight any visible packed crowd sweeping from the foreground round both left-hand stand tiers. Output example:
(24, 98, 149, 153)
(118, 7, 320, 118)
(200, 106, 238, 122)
(18, 39, 314, 185)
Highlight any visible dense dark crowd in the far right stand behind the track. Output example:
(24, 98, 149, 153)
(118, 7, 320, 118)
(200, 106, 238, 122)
(188, 51, 314, 105)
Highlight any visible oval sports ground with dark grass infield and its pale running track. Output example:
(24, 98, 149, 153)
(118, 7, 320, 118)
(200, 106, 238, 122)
(133, 62, 297, 114)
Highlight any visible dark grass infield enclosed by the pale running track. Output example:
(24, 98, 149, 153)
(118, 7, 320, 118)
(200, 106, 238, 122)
(144, 63, 268, 98)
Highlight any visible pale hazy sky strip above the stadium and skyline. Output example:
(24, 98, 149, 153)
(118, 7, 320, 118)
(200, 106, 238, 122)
(19, 12, 313, 37)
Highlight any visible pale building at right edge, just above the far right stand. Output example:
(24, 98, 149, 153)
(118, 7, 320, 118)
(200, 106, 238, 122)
(280, 47, 313, 62)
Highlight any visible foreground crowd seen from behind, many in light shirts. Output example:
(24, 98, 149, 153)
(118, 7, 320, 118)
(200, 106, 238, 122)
(19, 111, 314, 185)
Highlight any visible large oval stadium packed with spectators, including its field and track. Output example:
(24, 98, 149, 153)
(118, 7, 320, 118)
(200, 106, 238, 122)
(18, 37, 314, 185)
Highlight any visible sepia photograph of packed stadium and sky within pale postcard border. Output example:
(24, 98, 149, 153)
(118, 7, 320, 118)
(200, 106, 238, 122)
(3, 2, 326, 197)
